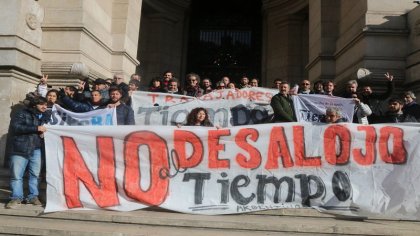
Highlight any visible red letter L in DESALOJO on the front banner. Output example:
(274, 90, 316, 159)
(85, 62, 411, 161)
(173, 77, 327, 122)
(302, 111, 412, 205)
(293, 126, 321, 166)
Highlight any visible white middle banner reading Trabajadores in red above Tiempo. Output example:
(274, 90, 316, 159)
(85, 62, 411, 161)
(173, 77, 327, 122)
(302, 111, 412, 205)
(132, 88, 278, 127)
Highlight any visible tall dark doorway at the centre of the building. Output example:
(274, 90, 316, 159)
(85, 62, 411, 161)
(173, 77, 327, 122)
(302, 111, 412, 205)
(187, 0, 262, 84)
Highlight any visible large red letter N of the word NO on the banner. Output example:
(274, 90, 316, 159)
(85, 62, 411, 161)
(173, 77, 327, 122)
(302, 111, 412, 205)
(62, 137, 119, 208)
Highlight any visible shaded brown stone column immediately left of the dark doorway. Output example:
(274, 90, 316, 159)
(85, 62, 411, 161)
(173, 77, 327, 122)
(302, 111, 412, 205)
(138, 0, 190, 85)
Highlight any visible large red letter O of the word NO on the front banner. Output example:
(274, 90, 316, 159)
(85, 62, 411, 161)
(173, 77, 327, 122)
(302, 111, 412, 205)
(124, 131, 169, 206)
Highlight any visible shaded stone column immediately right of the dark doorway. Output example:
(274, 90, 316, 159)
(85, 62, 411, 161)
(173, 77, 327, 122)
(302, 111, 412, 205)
(262, 1, 308, 87)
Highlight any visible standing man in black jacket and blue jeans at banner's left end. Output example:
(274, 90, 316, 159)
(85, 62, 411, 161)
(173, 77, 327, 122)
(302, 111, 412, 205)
(6, 97, 51, 209)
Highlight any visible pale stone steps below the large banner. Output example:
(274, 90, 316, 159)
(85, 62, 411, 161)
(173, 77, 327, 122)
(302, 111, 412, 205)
(0, 167, 420, 236)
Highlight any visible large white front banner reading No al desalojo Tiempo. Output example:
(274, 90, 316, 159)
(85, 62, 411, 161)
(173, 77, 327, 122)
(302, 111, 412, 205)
(45, 123, 420, 220)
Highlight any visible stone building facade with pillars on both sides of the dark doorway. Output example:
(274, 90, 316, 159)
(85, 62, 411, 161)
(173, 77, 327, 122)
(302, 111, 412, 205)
(0, 0, 420, 165)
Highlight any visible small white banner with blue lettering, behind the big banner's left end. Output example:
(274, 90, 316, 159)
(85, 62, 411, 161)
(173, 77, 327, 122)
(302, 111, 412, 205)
(49, 105, 117, 126)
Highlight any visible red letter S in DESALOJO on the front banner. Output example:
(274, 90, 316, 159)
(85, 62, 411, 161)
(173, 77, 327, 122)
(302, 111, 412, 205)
(235, 128, 261, 169)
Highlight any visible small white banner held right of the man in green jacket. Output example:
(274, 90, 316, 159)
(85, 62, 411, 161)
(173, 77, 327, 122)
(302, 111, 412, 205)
(293, 94, 355, 123)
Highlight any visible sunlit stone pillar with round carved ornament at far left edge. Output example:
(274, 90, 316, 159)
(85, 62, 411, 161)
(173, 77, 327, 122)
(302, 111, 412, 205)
(0, 0, 44, 164)
